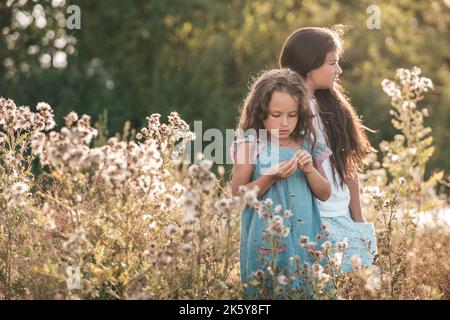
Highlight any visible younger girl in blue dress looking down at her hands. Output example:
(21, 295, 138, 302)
(232, 69, 331, 297)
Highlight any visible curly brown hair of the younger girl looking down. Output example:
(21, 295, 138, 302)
(237, 68, 315, 147)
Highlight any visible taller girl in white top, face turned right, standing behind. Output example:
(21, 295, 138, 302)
(279, 27, 377, 271)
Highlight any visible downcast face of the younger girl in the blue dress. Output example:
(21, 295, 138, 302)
(263, 91, 298, 140)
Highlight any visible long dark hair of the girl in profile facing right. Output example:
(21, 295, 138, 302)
(279, 26, 374, 186)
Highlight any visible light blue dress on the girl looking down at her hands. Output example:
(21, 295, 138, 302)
(232, 135, 331, 297)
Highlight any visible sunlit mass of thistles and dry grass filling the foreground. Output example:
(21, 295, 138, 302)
(0, 68, 450, 299)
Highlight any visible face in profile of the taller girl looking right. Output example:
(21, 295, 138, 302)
(306, 50, 342, 89)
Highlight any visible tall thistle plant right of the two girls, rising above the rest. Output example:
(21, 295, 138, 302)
(364, 67, 444, 299)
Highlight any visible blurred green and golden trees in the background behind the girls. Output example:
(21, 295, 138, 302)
(0, 0, 450, 175)
